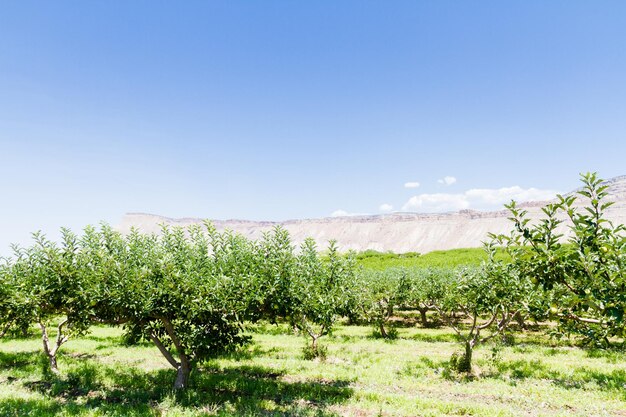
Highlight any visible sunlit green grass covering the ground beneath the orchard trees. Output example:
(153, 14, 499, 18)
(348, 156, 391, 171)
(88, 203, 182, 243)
(0, 324, 626, 417)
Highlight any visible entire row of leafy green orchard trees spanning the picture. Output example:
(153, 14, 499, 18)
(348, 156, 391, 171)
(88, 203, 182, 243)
(0, 174, 626, 389)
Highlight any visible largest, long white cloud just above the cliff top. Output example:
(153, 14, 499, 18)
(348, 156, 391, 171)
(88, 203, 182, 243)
(402, 186, 557, 213)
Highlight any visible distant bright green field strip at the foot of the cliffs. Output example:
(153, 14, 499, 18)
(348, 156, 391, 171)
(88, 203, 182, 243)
(357, 248, 508, 270)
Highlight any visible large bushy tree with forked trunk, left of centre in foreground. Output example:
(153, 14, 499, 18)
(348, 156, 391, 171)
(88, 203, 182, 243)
(109, 226, 250, 389)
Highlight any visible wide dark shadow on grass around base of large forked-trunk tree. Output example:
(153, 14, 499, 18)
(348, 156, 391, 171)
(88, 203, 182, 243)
(11, 362, 353, 417)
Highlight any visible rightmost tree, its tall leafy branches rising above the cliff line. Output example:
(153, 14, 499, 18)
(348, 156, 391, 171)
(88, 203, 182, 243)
(498, 173, 626, 346)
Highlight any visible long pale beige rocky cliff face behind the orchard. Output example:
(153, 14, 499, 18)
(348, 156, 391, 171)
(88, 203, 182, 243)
(118, 176, 626, 253)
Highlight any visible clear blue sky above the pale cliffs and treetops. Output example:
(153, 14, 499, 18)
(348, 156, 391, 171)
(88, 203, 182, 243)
(0, 1, 626, 253)
